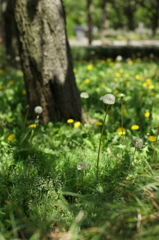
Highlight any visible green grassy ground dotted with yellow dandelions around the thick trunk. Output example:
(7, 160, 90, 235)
(0, 55, 159, 240)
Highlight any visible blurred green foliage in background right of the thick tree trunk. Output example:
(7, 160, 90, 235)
(63, 0, 159, 38)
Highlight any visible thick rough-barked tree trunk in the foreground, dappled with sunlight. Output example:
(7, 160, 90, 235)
(13, 0, 82, 123)
